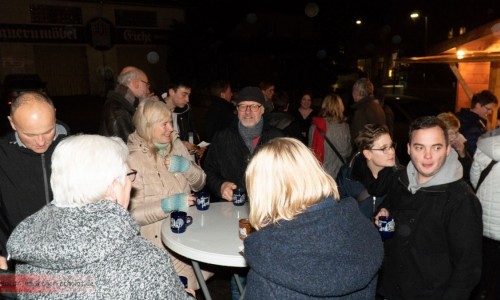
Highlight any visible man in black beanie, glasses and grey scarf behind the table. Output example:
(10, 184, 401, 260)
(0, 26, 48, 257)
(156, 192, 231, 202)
(204, 87, 284, 299)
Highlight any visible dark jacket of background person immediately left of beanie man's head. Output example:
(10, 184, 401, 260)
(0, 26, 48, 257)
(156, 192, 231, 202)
(205, 97, 236, 142)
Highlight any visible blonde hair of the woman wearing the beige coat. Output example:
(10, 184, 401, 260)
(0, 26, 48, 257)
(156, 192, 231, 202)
(132, 98, 172, 156)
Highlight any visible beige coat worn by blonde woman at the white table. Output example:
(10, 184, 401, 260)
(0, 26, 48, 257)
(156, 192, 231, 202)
(127, 132, 206, 289)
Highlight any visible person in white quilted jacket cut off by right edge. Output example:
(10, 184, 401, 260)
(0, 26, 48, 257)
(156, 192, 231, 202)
(470, 128, 500, 300)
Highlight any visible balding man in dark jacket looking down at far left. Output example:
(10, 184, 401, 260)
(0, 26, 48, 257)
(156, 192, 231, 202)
(0, 92, 69, 269)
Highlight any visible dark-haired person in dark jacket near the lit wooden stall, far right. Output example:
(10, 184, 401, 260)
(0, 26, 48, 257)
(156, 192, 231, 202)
(457, 90, 498, 156)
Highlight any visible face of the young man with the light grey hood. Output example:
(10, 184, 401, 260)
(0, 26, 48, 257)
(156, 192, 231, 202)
(408, 126, 450, 183)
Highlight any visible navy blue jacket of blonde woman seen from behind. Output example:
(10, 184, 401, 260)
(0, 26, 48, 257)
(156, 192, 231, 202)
(244, 197, 383, 300)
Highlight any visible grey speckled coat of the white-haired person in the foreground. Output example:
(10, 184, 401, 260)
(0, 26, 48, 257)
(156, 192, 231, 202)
(7, 200, 192, 300)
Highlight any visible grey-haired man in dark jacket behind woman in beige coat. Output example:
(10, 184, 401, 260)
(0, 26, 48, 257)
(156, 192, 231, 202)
(99, 66, 158, 143)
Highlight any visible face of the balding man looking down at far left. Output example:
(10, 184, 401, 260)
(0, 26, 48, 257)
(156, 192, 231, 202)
(8, 102, 56, 154)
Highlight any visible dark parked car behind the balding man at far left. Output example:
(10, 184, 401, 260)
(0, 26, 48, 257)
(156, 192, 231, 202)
(0, 74, 47, 135)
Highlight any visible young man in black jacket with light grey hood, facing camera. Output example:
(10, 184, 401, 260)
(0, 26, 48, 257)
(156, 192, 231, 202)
(376, 116, 483, 300)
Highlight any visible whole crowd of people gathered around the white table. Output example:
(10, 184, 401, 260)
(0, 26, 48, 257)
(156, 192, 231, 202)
(0, 66, 500, 300)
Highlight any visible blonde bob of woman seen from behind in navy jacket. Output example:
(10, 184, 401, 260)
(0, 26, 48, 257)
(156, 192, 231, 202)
(246, 138, 339, 230)
